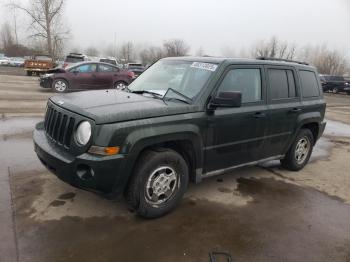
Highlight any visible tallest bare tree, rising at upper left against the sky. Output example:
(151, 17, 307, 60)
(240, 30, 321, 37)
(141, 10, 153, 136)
(9, 0, 69, 57)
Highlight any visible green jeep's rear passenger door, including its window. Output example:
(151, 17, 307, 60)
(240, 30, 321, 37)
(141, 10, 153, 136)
(265, 66, 303, 157)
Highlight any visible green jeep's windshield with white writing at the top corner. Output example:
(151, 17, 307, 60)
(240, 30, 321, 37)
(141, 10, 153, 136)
(129, 60, 217, 100)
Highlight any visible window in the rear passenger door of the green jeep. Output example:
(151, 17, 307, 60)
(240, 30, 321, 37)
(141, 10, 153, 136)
(268, 69, 296, 100)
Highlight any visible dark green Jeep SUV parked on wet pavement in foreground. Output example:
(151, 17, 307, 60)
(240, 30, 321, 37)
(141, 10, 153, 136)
(33, 57, 326, 217)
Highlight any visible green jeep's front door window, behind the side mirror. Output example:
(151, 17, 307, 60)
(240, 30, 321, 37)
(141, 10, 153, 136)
(218, 68, 261, 103)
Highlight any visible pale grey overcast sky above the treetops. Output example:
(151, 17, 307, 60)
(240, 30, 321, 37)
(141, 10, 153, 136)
(0, 0, 350, 55)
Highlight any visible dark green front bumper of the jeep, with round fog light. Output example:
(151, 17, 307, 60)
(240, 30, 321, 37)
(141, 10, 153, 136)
(33, 123, 126, 194)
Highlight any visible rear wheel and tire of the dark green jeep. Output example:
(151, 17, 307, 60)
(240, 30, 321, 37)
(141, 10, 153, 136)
(281, 129, 314, 171)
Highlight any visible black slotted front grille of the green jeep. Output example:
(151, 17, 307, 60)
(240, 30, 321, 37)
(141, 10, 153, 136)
(45, 103, 75, 148)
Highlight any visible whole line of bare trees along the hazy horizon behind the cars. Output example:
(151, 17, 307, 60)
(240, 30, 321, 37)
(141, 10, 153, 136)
(0, 0, 350, 75)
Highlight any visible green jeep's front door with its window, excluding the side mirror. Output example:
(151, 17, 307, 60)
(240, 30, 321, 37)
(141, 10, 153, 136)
(204, 66, 268, 173)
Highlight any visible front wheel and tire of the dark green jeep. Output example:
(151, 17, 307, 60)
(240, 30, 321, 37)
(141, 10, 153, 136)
(126, 149, 189, 218)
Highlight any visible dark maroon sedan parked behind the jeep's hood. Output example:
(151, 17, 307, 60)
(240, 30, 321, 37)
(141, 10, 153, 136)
(40, 62, 135, 93)
